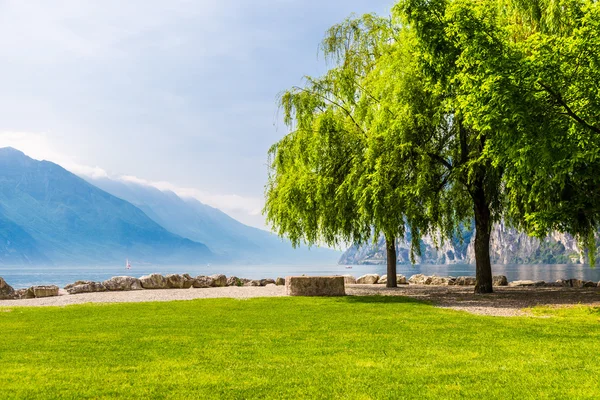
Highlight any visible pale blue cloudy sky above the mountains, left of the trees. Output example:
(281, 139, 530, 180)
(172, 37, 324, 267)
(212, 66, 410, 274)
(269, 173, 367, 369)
(0, 0, 393, 228)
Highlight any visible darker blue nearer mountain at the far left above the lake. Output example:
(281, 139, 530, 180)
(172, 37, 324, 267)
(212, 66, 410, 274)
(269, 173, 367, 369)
(0, 148, 213, 264)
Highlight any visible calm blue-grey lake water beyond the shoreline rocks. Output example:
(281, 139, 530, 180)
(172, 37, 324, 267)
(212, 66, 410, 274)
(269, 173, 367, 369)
(0, 264, 600, 289)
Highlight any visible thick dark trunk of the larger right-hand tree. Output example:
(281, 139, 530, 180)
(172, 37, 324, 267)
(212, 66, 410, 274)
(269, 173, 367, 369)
(473, 185, 494, 293)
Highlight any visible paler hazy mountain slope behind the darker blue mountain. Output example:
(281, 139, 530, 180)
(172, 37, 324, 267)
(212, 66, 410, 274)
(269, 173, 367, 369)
(86, 178, 340, 264)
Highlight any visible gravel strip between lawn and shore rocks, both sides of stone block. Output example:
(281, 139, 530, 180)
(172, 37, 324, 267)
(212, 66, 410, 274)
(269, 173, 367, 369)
(0, 285, 600, 317)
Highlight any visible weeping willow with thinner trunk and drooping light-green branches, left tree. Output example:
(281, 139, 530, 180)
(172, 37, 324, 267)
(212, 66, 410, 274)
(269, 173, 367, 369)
(264, 15, 414, 287)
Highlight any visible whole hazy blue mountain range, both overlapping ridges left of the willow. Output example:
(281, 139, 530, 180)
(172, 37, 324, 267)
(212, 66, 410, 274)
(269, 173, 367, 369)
(0, 148, 339, 265)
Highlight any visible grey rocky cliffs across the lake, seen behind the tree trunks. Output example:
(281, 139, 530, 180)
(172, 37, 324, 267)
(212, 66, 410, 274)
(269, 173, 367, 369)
(339, 223, 584, 264)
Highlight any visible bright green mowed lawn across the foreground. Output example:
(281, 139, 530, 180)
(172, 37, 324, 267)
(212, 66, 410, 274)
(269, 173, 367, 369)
(0, 297, 600, 399)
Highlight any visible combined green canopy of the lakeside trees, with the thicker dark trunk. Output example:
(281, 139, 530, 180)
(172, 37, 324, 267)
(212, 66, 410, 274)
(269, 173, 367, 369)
(265, 0, 600, 293)
